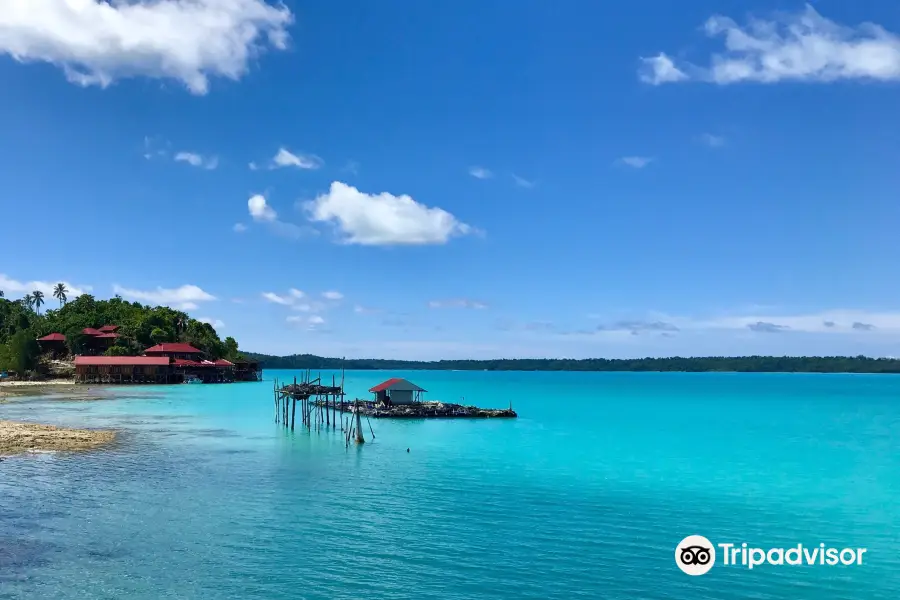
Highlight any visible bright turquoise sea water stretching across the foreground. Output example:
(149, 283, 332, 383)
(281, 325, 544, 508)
(0, 372, 900, 600)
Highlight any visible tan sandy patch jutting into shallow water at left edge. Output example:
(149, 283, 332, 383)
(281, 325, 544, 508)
(0, 421, 116, 456)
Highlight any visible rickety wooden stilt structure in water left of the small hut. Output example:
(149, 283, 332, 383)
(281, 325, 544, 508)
(274, 371, 375, 446)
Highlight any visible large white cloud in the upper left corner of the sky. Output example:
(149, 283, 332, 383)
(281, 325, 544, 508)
(0, 0, 293, 94)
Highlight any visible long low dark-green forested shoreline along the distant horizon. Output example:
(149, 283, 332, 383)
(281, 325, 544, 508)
(244, 352, 900, 373)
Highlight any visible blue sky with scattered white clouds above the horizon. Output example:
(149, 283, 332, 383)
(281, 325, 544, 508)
(0, 0, 900, 360)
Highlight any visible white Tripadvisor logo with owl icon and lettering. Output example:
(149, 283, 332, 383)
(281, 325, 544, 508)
(675, 535, 866, 575)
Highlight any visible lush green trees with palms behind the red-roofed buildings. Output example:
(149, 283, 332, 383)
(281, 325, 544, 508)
(0, 284, 240, 373)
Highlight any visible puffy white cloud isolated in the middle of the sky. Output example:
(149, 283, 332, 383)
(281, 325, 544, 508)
(305, 181, 472, 246)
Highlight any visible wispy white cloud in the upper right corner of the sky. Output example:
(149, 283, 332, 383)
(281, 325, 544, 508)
(641, 4, 900, 85)
